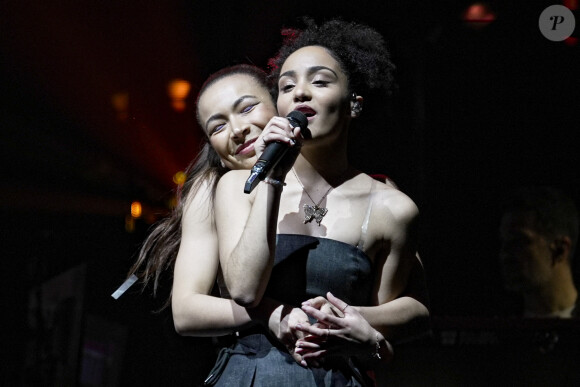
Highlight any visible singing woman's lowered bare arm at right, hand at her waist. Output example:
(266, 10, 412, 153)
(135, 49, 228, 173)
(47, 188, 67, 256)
(298, 195, 429, 360)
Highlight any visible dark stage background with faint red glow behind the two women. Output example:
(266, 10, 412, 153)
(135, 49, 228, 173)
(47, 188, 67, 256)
(0, 0, 580, 386)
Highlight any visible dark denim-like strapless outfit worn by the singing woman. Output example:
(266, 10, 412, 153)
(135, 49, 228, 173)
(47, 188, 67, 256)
(210, 234, 374, 386)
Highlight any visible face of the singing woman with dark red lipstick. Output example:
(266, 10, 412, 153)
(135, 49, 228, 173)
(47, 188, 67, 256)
(277, 46, 350, 145)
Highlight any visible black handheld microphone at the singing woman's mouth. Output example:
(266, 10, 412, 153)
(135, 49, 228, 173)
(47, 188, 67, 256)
(244, 110, 308, 193)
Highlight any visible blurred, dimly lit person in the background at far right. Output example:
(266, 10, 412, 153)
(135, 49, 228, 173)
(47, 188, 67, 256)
(500, 187, 580, 318)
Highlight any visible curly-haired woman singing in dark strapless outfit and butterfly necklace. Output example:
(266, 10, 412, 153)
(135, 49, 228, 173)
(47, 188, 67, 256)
(215, 20, 429, 386)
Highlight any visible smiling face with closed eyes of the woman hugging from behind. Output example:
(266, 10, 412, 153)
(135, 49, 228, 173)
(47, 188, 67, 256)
(197, 74, 276, 169)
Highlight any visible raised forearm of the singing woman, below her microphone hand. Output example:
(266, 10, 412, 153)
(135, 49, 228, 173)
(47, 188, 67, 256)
(223, 184, 282, 307)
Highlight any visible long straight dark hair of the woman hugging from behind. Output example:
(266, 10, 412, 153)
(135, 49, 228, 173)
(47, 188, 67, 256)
(128, 64, 269, 310)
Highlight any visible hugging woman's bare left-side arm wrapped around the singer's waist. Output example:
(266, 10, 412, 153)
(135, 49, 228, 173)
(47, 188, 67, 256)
(172, 180, 308, 361)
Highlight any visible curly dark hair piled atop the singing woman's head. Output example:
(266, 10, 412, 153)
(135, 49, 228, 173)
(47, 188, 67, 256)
(268, 18, 396, 97)
